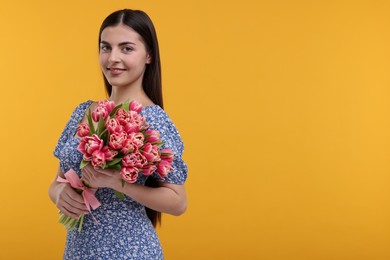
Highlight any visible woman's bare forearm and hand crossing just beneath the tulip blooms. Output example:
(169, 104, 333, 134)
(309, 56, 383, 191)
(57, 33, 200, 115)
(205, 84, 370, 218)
(82, 165, 187, 216)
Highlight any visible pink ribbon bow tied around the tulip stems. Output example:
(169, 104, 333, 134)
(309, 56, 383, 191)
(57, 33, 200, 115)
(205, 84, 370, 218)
(57, 169, 101, 212)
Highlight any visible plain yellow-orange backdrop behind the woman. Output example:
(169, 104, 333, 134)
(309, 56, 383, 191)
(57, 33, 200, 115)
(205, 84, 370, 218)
(0, 0, 390, 260)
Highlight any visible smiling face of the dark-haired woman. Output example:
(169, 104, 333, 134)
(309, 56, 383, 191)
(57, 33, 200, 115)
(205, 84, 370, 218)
(99, 24, 151, 87)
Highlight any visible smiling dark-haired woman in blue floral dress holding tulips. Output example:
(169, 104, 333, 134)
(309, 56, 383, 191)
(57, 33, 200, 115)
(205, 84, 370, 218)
(49, 9, 187, 260)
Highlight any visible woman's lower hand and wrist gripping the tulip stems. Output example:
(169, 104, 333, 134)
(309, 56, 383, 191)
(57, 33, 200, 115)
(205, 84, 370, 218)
(49, 167, 88, 219)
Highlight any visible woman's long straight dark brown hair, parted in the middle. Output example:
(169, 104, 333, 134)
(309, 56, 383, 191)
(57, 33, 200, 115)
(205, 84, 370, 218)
(98, 9, 164, 227)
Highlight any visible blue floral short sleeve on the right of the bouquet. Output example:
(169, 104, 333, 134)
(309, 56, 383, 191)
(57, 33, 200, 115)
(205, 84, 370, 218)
(149, 107, 188, 184)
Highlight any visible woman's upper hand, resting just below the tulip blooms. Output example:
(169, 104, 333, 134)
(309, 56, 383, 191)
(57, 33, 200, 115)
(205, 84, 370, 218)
(82, 164, 121, 189)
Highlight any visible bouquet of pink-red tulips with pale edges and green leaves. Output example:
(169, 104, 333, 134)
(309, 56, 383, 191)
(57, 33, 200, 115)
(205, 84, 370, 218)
(60, 100, 174, 231)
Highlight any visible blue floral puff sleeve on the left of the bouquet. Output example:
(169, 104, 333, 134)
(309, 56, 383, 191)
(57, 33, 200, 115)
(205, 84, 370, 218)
(53, 101, 90, 159)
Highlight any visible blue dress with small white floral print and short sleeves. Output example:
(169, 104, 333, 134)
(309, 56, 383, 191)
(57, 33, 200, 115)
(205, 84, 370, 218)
(54, 100, 187, 260)
